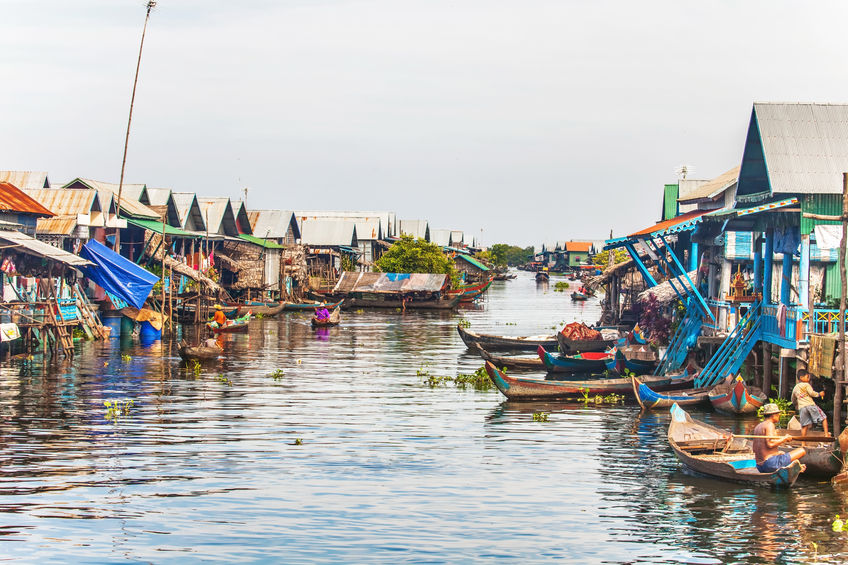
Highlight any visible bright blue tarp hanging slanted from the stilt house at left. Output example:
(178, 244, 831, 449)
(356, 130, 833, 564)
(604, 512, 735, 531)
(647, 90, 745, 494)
(80, 239, 159, 308)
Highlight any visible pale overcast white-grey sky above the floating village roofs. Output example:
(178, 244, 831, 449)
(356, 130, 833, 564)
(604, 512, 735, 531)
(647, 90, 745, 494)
(0, 0, 848, 246)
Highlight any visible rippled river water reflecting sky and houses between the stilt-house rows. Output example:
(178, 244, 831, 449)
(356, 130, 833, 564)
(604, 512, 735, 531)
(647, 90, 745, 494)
(0, 273, 848, 563)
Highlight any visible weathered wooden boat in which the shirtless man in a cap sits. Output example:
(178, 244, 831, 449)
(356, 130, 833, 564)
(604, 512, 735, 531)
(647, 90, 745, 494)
(668, 404, 801, 487)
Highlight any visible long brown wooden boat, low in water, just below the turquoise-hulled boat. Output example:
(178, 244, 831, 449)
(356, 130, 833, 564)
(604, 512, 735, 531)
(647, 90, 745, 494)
(486, 361, 681, 400)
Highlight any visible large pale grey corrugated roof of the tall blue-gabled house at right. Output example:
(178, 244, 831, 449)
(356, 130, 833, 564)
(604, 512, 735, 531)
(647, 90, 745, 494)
(743, 102, 848, 194)
